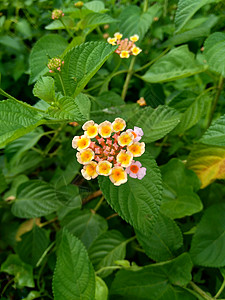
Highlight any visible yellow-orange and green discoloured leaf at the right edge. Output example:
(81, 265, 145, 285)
(187, 145, 225, 188)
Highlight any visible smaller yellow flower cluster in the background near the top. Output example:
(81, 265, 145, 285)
(107, 32, 142, 58)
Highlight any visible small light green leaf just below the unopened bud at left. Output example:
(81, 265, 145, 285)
(33, 76, 55, 104)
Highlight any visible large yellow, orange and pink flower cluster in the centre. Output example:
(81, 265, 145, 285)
(72, 118, 146, 186)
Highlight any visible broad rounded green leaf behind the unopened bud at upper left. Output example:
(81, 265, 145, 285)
(29, 34, 68, 84)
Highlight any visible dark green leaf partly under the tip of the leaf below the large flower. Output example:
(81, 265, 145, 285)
(136, 214, 183, 262)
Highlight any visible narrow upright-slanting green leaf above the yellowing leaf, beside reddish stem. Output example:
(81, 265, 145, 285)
(173, 94, 212, 134)
